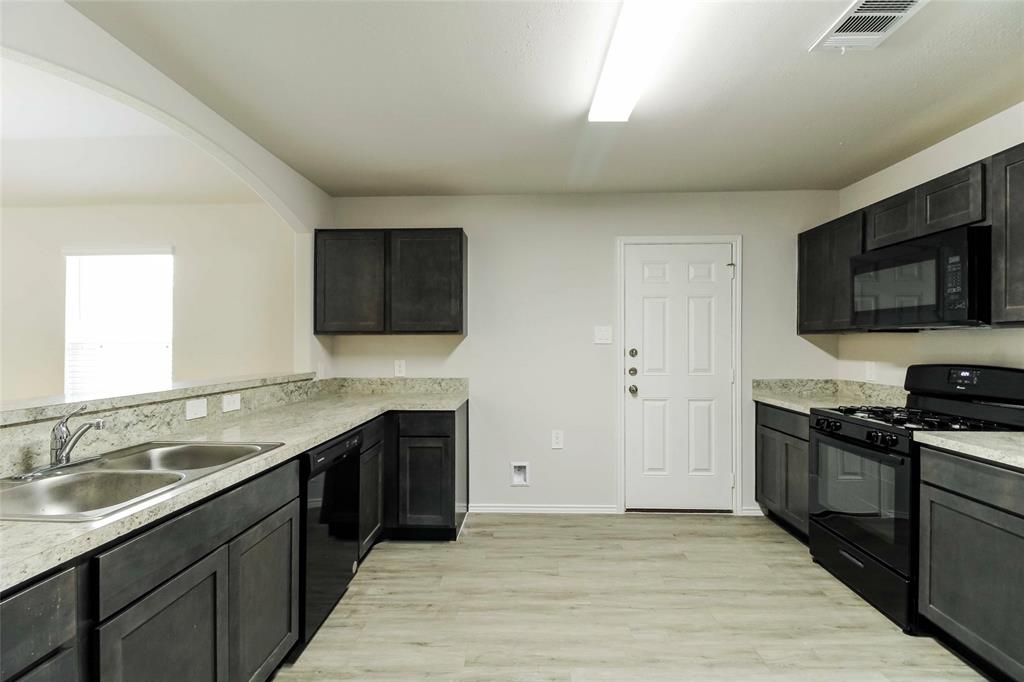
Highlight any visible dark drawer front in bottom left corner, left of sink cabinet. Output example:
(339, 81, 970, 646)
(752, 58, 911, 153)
(0, 568, 78, 681)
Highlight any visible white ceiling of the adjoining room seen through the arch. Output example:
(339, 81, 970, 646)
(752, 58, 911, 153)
(0, 59, 259, 206)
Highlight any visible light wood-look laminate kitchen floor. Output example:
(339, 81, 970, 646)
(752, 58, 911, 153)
(276, 514, 980, 682)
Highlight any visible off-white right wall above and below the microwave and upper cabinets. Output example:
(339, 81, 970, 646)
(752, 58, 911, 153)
(839, 102, 1024, 384)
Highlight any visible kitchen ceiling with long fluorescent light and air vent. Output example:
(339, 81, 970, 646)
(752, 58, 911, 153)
(73, 0, 1024, 196)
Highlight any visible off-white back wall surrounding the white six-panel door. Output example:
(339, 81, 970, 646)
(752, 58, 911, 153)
(325, 191, 836, 507)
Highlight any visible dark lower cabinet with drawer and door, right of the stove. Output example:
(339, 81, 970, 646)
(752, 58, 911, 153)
(918, 449, 1024, 680)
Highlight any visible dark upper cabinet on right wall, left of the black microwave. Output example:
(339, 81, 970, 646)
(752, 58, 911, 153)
(797, 211, 864, 334)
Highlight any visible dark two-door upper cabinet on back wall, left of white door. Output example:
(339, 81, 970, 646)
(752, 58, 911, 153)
(313, 227, 467, 334)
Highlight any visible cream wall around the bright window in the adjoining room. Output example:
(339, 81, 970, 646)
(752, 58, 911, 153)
(0, 203, 296, 400)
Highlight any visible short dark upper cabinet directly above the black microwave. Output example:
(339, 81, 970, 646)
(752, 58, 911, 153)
(864, 161, 986, 250)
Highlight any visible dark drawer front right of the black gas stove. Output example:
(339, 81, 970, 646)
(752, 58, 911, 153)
(921, 447, 1024, 516)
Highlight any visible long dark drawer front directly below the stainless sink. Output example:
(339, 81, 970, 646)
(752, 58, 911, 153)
(95, 462, 299, 620)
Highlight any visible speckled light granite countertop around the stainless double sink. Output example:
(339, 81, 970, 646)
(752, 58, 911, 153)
(0, 391, 468, 590)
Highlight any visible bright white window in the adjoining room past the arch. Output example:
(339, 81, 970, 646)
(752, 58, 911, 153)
(65, 253, 174, 398)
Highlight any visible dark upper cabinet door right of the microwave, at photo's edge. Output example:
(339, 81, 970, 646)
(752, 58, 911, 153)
(991, 144, 1024, 323)
